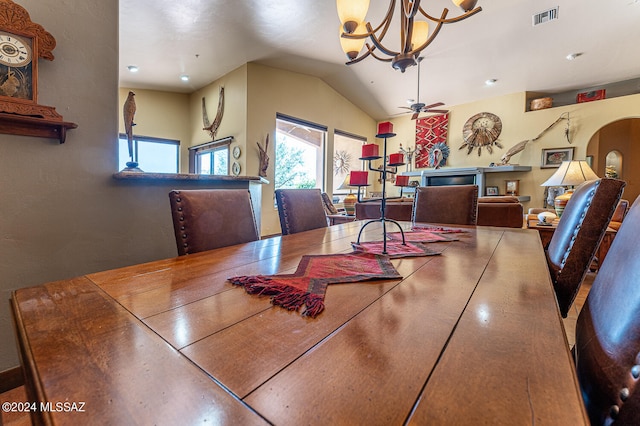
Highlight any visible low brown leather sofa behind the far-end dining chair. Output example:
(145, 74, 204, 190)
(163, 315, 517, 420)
(356, 196, 524, 228)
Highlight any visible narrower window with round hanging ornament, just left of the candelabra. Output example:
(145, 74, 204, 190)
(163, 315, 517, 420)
(333, 130, 367, 203)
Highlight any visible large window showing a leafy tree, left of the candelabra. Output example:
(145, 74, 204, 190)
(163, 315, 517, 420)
(274, 114, 327, 189)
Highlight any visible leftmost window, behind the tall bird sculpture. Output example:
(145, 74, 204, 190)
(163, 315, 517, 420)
(118, 133, 180, 173)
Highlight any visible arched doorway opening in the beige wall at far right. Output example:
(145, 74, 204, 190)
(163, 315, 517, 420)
(587, 118, 640, 203)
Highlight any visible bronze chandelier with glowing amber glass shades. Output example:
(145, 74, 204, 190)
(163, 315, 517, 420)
(336, 0, 482, 72)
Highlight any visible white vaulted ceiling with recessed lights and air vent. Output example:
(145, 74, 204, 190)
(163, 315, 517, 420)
(119, 0, 640, 119)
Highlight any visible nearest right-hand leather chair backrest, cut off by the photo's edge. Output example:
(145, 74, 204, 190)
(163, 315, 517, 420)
(576, 197, 640, 425)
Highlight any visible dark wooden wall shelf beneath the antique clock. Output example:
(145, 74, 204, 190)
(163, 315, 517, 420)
(0, 113, 78, 143)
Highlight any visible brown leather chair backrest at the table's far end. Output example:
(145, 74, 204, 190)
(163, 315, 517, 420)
(413, 185, 478, 225)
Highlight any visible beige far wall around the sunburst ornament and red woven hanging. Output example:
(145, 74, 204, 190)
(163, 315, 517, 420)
(389, 93, 640, 209)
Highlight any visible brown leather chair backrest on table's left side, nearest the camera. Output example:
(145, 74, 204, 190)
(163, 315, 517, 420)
(169, 189, 260, 256)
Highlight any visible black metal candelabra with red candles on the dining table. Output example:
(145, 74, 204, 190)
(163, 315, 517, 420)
(351, 133, 408, 254)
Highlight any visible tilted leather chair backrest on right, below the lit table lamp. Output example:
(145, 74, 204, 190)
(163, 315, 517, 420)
(547, 179, 625, 317)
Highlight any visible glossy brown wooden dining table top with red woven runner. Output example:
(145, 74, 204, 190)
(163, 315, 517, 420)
(11, 222, 588, 425)
